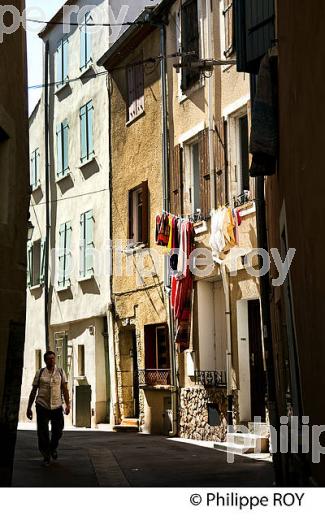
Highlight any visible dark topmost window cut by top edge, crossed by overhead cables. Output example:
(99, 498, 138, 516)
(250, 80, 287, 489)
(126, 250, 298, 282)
(181, 0, 200, 92)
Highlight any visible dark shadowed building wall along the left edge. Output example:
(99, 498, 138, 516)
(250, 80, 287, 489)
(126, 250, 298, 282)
(0, 0, 29, 487)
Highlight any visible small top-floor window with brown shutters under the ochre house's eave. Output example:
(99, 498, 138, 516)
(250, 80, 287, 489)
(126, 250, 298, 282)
(127, 58, 144, 122)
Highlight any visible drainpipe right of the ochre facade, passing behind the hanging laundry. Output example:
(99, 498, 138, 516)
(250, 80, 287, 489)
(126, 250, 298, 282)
(160, 23, 177, 437)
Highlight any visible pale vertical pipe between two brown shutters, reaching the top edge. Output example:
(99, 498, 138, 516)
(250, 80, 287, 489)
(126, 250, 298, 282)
(205, 0, 216, 209)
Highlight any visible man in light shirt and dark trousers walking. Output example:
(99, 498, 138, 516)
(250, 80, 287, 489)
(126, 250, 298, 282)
(26, 351, 70, 466)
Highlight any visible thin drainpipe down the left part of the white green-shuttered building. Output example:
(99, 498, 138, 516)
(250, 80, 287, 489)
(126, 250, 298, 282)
(44, 41, 51, 350)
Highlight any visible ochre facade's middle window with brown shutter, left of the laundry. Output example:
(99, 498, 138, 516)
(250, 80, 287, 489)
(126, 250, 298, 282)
(129, 181, 149, 244)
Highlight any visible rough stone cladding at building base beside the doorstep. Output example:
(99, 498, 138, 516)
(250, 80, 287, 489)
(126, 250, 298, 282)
(179, 386, 238, 441)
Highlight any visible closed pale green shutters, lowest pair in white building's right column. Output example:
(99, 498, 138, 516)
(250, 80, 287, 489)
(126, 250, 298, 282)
(79, 210, 94, 278)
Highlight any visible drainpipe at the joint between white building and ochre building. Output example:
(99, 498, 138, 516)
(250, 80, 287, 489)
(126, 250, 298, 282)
(107, 74, 120, 425)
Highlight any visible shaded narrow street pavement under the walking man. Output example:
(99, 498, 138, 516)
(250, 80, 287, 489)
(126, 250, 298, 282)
(13, 431, 273, 487)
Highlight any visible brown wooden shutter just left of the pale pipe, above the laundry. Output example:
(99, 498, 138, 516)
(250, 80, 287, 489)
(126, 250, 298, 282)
(199, 128, 211, 217)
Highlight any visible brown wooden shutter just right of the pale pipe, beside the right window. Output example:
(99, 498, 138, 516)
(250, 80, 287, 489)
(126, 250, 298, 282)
(215, 117, 228, 207)
